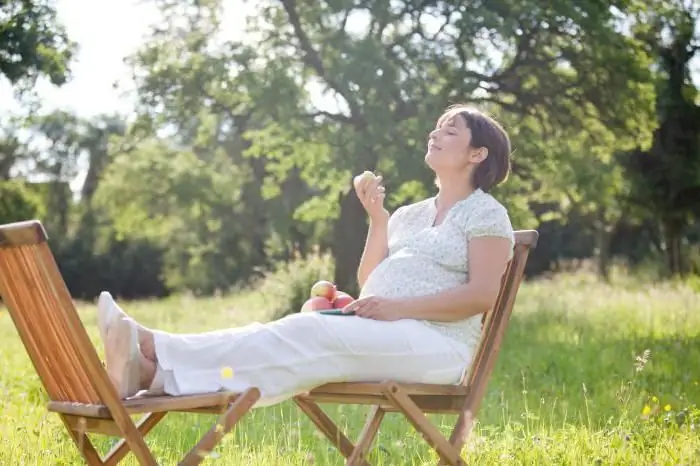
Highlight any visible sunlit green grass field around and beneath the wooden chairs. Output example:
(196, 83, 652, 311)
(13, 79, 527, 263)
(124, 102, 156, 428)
(0, 275, 700, 465)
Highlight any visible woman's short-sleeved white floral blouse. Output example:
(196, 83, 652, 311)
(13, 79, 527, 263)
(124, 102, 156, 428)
(360, 189, 515, 346)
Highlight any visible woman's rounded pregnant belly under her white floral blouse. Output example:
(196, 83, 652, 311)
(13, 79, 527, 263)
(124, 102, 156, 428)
(360, 256, 466, 298)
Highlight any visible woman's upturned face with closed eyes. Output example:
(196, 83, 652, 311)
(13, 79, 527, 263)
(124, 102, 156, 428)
(425, 112, 474, 174)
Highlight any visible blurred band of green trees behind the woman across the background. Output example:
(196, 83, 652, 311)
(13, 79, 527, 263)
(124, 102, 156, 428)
(0, 0, 700, 298)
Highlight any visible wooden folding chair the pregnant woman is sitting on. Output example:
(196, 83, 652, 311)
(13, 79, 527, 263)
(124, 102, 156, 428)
(294, 230, 539, 465)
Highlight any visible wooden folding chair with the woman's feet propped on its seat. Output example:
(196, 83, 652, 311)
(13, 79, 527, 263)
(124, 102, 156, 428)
(0, 221, 260, 466)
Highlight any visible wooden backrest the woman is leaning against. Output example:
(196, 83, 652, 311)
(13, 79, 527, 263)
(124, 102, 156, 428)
(462, 230, 539, 417)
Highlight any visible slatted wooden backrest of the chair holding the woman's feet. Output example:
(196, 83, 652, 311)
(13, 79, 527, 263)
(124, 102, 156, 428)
(0, 220, 120, 410)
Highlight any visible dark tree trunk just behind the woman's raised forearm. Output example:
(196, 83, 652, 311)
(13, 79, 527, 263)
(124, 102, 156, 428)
(331, 189, 368, 295)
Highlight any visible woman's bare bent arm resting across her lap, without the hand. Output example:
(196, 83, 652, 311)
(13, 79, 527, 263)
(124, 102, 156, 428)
(399, 236, 511, 322)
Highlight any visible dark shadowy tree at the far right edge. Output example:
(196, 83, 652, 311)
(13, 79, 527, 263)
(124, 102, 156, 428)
(627, 1, 700, 275)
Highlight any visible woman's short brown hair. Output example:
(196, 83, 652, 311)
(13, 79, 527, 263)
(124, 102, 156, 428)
(438, 104, 511, 192)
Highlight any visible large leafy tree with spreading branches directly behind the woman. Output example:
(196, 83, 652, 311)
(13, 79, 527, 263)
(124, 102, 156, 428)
(121, 0, 668, 291)
